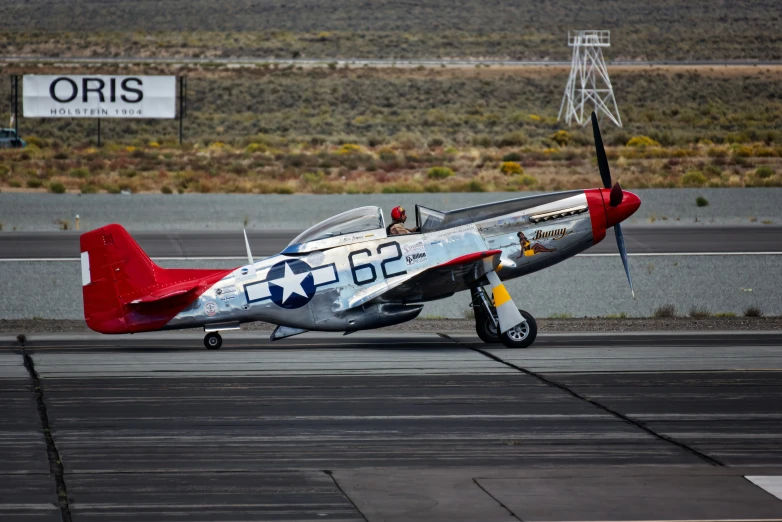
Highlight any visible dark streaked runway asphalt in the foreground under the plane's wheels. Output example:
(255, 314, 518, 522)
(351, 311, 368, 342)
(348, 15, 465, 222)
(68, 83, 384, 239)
(0, 332, 782, 521)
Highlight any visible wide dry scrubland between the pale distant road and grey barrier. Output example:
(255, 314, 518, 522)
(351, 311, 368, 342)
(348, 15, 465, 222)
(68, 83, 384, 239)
(0, 65, 782, 194)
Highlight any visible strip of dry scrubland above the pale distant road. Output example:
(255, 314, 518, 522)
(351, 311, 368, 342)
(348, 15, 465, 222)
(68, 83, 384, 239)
(0, 0, 782, 60)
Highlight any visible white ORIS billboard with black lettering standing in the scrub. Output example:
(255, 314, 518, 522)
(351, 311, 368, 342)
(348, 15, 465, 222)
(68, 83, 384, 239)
(23, 75, 176, 118)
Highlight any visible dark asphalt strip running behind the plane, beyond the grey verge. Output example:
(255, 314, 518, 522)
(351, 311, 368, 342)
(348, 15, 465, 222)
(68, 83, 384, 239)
(0, 225, 782, 259)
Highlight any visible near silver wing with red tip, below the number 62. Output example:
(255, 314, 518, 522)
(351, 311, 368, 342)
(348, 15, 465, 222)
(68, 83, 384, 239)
(335, 250, 502, 311)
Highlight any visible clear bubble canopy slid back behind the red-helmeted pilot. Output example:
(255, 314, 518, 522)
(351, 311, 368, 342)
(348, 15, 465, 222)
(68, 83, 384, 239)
(282, 207, 386, 254)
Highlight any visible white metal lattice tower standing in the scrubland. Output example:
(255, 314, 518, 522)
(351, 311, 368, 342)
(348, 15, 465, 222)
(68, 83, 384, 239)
(558, 31, 622, 127)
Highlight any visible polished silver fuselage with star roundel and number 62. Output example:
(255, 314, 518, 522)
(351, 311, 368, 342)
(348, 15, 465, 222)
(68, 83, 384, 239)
(165, 189, 637, 331)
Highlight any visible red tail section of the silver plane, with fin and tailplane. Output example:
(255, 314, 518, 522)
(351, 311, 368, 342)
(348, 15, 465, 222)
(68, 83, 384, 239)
(81, 225, 231, 333)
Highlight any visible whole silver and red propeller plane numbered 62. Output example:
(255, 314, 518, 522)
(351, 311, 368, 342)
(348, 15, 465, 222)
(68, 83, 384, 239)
(80, 113, 641, 349)
